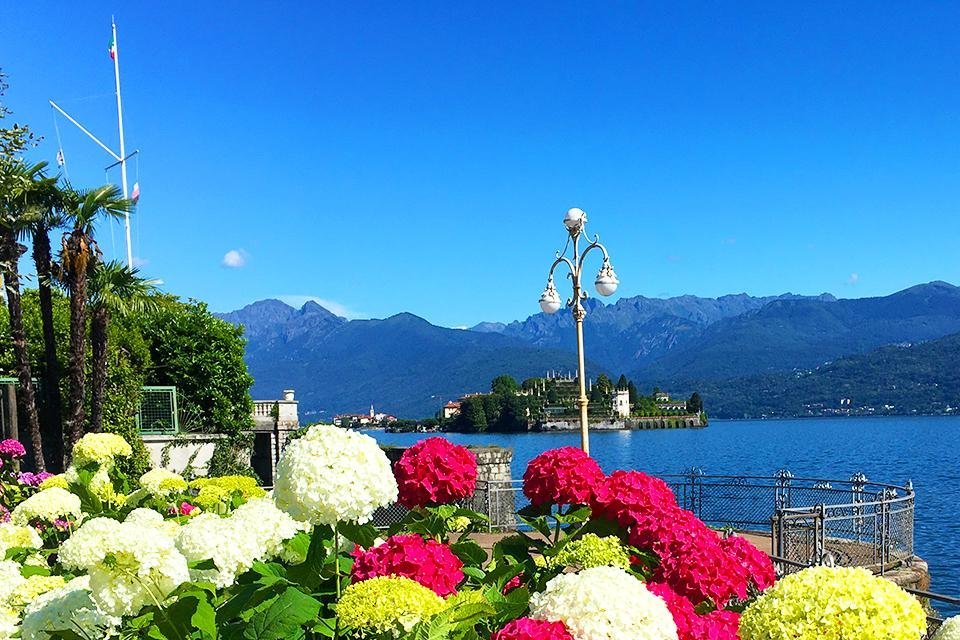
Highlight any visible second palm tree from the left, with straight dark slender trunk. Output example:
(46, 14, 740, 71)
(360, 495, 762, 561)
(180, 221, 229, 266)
(28, 189, 67, 472)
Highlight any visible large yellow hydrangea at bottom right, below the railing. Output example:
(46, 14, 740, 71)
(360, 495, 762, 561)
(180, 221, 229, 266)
(740, 567, 927, 640)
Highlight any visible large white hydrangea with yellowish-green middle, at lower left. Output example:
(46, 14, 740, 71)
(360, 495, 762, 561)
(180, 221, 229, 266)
(60, 518, 189, 616)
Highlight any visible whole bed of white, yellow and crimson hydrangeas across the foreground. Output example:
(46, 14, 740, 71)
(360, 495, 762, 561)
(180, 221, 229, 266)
(0, 426, 932, 640)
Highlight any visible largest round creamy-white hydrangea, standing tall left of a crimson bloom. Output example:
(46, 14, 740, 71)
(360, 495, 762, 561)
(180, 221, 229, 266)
(273, 425, 397, 525)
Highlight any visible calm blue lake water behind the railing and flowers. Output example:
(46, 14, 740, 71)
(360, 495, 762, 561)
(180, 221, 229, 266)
(371, 417, 960, 595)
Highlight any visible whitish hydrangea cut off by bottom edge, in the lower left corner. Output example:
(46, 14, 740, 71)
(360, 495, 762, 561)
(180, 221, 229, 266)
(20, 576, 120, 640)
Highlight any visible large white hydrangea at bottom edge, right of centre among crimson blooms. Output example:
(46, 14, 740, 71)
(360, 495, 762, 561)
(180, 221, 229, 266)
(530, 567, 677, 640)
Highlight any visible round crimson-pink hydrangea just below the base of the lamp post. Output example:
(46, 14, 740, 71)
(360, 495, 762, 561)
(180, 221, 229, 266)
(523, 447, 604, 507)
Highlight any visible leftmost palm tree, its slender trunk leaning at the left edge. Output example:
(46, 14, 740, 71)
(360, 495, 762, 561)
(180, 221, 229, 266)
(0, 157, 56, 471)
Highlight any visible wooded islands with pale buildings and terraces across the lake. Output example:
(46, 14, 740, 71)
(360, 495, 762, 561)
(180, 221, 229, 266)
(333, 371, 707, 433)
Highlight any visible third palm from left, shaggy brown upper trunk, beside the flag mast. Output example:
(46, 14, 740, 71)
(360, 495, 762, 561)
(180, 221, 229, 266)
(60, 185, 131, 451)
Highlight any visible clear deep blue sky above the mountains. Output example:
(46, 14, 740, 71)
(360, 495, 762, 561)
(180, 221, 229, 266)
(0, 2, 960, 326)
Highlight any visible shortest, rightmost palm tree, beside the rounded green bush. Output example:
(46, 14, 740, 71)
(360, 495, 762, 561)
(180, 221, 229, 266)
(90, 260, 159, 431)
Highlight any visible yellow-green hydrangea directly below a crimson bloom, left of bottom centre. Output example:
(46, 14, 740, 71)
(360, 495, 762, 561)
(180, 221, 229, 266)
(336, 576, 447, 638)
